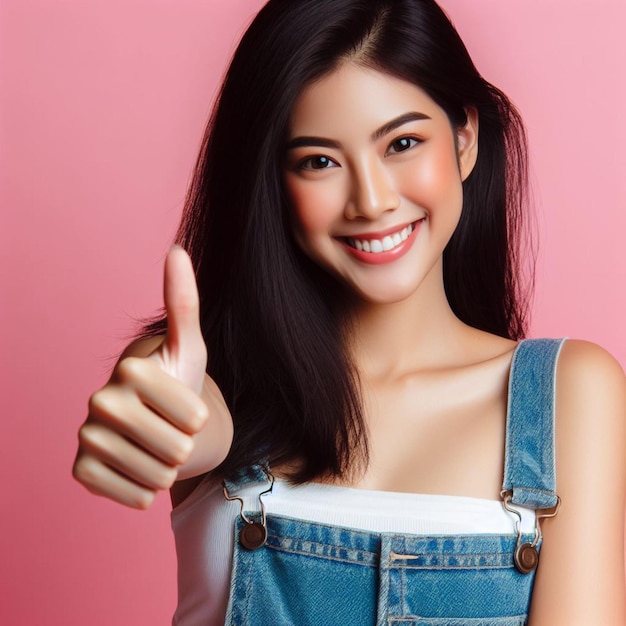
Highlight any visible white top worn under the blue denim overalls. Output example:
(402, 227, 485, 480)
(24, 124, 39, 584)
(172, 478, 535, 626)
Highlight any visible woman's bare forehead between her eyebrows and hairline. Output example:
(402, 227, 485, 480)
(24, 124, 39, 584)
(290, 63, 447, 137)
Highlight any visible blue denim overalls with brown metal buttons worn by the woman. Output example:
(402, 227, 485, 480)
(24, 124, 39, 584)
(225, 339, 563, 626)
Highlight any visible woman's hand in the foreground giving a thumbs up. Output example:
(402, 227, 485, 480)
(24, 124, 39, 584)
(73, 246, 232, 509)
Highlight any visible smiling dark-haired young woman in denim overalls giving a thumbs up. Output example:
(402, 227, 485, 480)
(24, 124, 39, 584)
(75, 0, 626, 626)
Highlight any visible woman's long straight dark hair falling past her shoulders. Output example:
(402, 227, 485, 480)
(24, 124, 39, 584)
(146, 0, 526, 481)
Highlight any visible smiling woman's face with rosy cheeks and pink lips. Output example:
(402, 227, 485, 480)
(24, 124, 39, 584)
(284, 63, 478, 303)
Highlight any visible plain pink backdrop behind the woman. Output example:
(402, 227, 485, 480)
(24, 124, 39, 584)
(0, 0, 626, 626)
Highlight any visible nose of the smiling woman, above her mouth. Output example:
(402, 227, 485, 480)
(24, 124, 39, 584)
(345, 158, 400, 220)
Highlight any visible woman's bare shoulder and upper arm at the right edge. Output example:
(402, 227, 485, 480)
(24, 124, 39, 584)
(529, 340, 626, 626)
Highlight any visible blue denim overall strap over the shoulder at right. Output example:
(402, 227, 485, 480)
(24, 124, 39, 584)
(502, 339, 565, 509)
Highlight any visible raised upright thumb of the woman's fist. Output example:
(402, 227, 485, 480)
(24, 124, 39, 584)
(153, 246, 207, 393)
